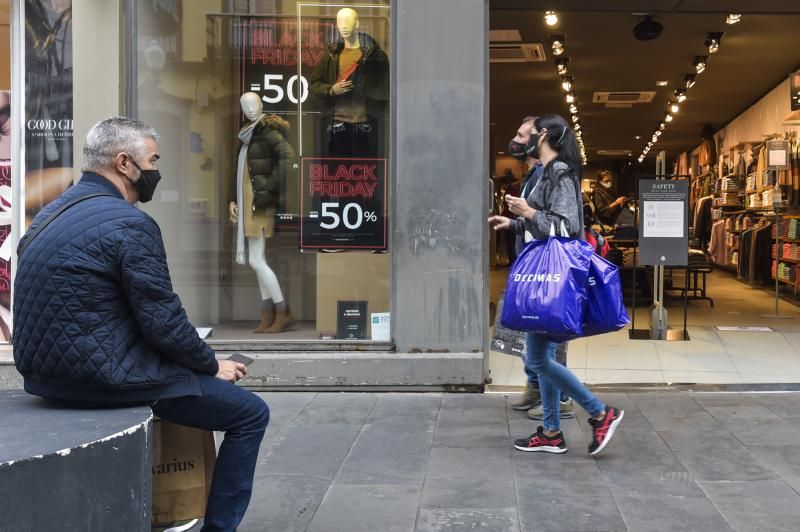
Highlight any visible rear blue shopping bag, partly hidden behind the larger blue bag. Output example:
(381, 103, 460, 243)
(582, 253, 631, 336)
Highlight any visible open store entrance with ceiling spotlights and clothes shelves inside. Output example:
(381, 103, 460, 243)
(488, 1, 800, 387)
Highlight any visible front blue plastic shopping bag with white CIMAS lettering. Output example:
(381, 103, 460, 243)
(501, 236, 594, 338)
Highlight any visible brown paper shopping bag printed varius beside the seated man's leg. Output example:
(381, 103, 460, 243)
(152, 418, 217, 525)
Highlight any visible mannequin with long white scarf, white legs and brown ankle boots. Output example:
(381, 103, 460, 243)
(228, 92, 295, 333)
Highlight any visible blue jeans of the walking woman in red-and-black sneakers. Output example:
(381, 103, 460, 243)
(525, 333, 605, 432)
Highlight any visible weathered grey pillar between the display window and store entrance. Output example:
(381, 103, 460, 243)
(392, 0, 489, 353)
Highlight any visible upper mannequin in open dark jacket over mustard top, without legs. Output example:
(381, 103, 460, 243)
(309, 7, 389, 157)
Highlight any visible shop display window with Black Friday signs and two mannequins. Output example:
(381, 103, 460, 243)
(137, 0, 391, 344)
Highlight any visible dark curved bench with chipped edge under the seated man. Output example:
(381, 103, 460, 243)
(0, 390, 153, 532)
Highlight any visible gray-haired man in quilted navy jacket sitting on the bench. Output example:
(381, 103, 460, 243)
(14, 117, 269, 532)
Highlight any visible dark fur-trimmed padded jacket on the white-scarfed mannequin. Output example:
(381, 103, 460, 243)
(228, 115, 296, 209)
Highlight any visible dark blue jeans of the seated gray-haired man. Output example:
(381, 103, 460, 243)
(152, 375, 269, 532)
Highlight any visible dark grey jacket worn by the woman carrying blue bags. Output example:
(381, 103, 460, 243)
(511, 159, 584, 253)
